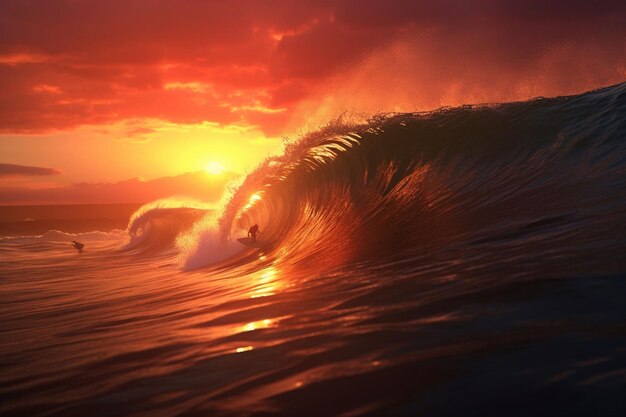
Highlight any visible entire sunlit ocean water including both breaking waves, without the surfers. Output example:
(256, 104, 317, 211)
(0, 84, 626, 417)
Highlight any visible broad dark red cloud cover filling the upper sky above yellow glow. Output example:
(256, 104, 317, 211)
(0, 0, 626, 134)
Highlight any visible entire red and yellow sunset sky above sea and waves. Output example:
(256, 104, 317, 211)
(0, 0, 626, 204)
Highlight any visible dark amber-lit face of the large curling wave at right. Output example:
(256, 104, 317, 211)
(221, 84, 626, 268)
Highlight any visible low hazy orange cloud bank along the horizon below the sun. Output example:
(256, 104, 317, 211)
(0, 171, 237, 204)
